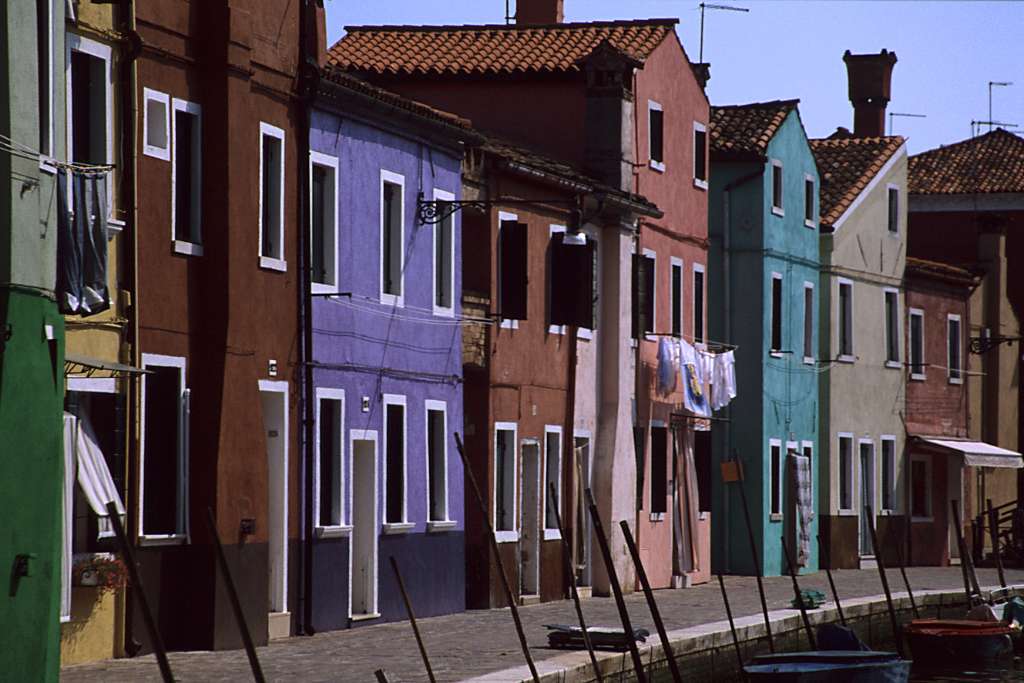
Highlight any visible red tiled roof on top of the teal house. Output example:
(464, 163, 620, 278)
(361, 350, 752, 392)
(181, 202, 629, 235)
(708, 99, 800, 159)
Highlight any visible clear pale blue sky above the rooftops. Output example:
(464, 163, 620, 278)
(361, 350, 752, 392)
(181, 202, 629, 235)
(326, 0, 1024, 154)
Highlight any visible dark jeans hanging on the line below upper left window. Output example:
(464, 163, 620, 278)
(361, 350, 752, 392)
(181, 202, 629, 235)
(57, 168, 110, 315)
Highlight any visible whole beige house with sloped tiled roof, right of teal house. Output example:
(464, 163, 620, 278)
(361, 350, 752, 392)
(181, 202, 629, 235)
(811, 129, 907, 567)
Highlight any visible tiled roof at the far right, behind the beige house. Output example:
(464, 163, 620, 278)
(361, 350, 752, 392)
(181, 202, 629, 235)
(909, 128, 1024, 195)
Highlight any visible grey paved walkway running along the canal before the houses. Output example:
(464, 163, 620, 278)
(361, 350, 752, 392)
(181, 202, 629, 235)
(60, 567, 1024, 683)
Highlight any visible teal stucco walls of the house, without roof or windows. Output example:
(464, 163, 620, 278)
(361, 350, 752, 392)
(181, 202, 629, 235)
(709, 112, 818, 575)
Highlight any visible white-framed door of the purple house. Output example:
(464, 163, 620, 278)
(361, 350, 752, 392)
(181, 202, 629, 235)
(351, 434, 378, 617)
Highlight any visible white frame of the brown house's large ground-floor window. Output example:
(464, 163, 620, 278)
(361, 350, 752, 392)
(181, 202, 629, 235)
(137, 353, 190, 546)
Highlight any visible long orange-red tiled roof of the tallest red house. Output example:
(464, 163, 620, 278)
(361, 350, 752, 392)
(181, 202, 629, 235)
(328, 18, 678, 75)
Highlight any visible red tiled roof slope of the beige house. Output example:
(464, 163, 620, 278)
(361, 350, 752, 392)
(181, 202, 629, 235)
(808, 135, 903, 228)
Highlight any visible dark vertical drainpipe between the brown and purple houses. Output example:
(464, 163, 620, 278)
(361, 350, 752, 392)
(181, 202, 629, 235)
(295, 0, 319, 636)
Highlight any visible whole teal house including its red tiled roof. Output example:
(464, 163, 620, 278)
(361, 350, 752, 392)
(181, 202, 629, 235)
(708, 100, 819, 575)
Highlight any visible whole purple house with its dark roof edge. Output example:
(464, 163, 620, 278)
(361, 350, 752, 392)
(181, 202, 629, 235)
(306, 69, 473, 631)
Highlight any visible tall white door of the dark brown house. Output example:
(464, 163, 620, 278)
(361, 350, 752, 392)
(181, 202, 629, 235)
(260, 381, 288, 612)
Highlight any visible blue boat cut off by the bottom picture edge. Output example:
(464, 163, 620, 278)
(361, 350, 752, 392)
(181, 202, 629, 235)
(743, 650, 910, 683)
